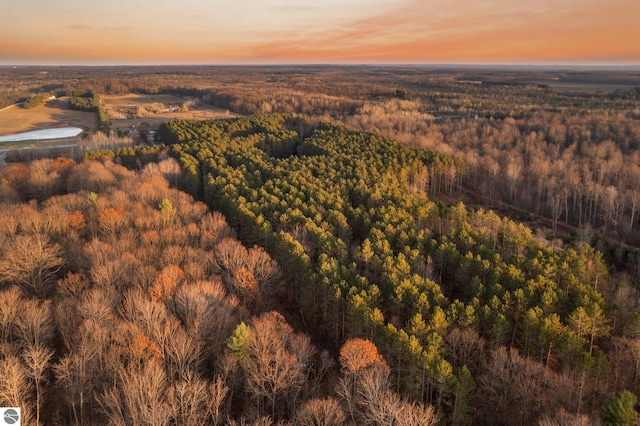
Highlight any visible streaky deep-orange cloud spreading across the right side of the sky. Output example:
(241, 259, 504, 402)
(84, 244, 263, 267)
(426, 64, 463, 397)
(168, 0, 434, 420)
(244, 0, 640, 63)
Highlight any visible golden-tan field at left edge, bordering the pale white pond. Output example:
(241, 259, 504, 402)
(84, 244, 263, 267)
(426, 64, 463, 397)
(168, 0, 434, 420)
(0, 98, 98, 136)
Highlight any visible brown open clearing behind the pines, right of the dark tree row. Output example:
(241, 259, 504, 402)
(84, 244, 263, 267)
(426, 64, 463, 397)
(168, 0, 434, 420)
(100, 94, 236, 133)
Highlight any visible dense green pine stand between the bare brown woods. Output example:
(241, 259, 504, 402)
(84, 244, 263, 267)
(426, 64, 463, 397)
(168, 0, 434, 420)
(161, 115, 639, 424)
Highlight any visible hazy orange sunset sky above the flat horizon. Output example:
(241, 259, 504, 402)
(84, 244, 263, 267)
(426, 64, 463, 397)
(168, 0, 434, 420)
(0, 0, 640, 65)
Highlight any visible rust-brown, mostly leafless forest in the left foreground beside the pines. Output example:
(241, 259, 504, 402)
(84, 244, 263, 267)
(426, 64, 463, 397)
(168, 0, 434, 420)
(0, 158, 436, 425)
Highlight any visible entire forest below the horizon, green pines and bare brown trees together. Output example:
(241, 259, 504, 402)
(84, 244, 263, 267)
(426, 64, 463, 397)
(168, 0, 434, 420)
(0, 67, 640, 425)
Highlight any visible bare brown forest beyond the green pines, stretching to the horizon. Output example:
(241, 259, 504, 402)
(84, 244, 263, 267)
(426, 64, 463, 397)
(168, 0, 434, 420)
(5, 66, 640, 248)
